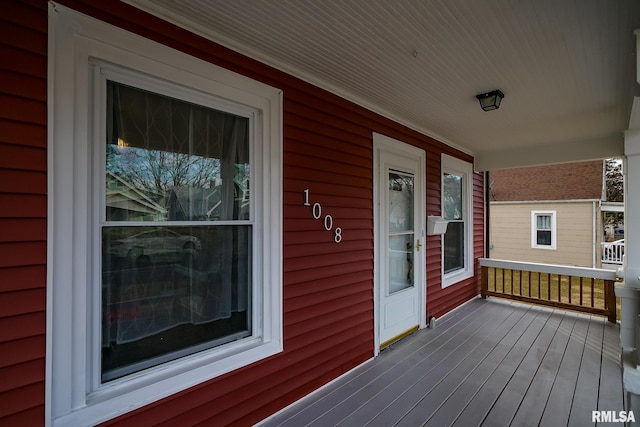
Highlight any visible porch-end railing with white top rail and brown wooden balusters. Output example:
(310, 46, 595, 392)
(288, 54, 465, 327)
(479, 258, 617, 322)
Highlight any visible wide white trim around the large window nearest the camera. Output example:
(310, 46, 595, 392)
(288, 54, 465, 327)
(45, 2, 283, 426)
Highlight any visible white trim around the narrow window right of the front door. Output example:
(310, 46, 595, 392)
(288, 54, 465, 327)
(440, 154, 474, 288)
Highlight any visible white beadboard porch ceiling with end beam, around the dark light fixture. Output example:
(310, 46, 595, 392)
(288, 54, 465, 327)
(128, 0, 640, 170)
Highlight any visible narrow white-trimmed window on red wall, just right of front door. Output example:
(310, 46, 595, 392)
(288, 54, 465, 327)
(442, 154, 473, 286)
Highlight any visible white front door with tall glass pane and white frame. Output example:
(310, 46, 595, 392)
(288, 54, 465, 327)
(373, 134, 426, 349)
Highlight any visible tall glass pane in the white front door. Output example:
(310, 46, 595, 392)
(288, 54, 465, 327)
(388, 171, 414, 294)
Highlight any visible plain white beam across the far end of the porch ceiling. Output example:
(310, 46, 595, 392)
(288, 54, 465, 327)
(474, 133, 624, 171)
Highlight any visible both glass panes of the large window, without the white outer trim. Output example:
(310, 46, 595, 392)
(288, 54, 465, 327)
(100, 80, 253, 382)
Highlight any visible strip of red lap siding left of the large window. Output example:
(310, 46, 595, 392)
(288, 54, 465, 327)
(0, 1, 47, 426)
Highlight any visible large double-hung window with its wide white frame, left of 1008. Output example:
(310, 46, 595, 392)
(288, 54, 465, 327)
(47, 5, 282, 425)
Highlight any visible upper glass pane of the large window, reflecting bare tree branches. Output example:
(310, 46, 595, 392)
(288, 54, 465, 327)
(105, 81, 250, 221)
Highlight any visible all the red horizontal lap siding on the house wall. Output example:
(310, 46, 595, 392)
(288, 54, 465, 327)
(0, 0, 484, 426)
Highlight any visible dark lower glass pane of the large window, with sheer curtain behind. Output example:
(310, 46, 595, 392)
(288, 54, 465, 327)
(102, 225, 252, 381)
